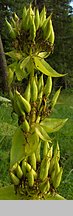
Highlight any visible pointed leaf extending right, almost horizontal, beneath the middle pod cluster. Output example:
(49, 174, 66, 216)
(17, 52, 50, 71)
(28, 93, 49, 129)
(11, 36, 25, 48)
(40, 118, 68, 133)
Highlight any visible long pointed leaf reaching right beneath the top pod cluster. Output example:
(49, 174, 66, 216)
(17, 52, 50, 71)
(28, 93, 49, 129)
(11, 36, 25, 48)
(34, 56, 66, 77)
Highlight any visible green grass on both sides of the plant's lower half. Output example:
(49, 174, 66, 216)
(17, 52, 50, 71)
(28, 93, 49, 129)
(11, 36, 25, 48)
(0, 91, 73, 200)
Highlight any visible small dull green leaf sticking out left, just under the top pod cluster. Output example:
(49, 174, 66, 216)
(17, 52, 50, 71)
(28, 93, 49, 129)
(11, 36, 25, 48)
(5, 50, 22, 60)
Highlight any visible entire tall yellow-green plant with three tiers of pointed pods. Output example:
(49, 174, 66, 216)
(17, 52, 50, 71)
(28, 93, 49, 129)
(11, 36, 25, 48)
(6, 4, 67, 200)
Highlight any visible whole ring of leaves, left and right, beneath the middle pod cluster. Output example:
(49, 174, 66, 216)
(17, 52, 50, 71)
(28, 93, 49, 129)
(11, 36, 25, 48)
(10, 118, 68, 167)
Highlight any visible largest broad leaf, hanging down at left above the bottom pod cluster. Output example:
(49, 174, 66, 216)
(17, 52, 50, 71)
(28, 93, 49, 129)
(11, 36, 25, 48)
(10, 128, 26, 167)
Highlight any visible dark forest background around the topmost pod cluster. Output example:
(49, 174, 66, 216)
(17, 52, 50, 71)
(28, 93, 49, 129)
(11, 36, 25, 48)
(0, 0, 73, 88)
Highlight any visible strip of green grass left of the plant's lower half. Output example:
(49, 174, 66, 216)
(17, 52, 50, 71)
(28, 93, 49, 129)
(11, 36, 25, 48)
(0, 103, 17, 187)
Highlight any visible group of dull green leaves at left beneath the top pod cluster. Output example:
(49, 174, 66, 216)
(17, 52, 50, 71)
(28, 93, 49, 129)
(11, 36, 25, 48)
(7, 54, 34, 85)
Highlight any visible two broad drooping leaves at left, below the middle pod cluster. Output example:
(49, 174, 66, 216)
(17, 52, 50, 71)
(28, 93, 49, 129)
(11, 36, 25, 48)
(10, 127, 39, 167)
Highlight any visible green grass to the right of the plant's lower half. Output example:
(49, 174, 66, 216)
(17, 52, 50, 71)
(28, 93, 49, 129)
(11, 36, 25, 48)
(52, 89, 73, 200)
